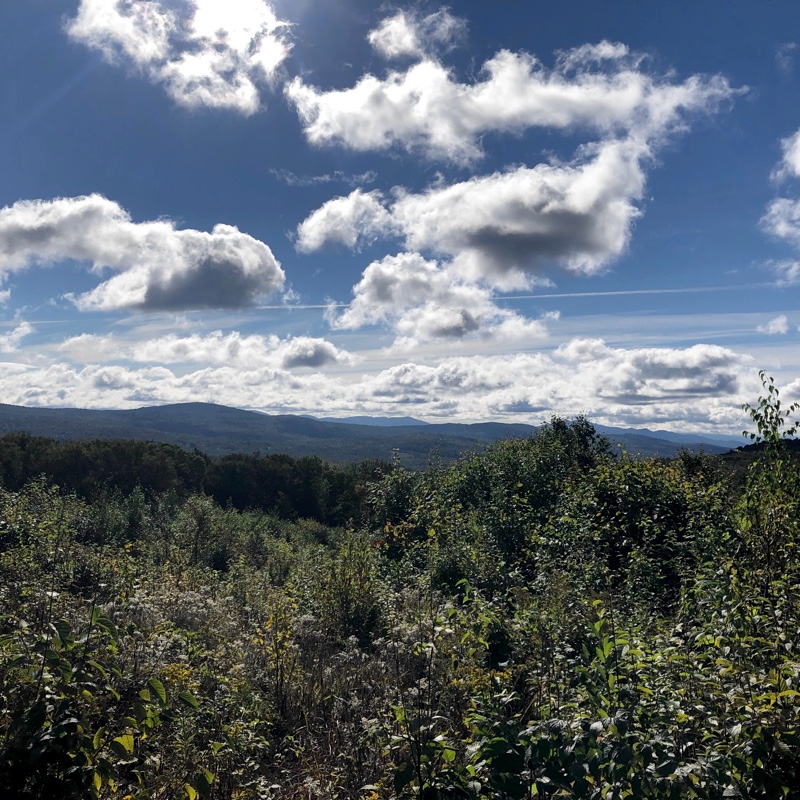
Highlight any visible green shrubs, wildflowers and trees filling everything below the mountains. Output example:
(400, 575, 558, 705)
(0, 374, 800, 800)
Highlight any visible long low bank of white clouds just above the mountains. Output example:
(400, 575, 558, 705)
(0, 332, 758, 430)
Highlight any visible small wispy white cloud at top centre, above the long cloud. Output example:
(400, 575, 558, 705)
(367, 9, 466, 58)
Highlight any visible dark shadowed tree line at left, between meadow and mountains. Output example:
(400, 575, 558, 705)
(0, 433, 391, 526)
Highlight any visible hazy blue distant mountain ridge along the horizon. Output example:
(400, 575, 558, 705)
(0, 403, 741, 469)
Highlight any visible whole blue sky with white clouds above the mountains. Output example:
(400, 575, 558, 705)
(0, 0, 800, 434)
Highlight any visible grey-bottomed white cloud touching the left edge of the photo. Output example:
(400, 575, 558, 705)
(0, 194, 285, 311)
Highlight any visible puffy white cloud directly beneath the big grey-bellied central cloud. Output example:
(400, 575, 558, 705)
(326, 253, 558, 348)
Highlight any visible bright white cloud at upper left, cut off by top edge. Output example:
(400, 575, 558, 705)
(67, 0, 290, 114)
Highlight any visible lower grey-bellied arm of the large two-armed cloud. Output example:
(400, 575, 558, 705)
(298, 141, 649, 289)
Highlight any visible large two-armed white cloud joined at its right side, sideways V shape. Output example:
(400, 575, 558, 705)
(296, 38, 736, 289)
